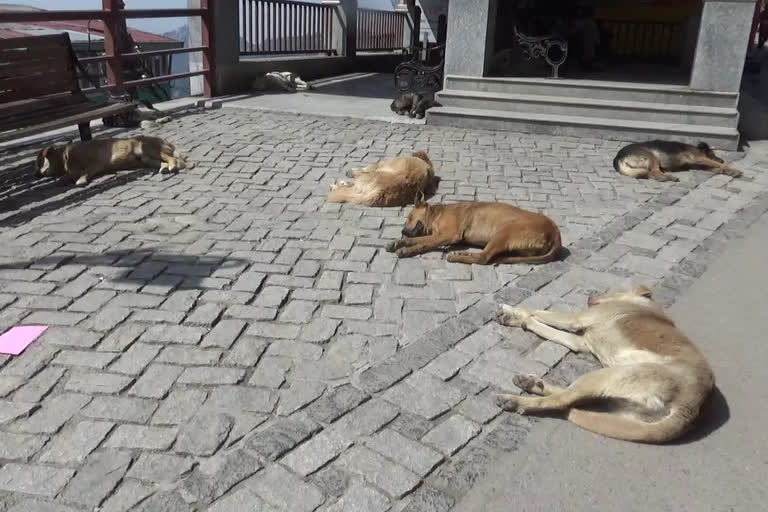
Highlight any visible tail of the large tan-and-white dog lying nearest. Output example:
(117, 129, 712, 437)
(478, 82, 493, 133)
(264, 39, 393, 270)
(566, 409, 690, 443)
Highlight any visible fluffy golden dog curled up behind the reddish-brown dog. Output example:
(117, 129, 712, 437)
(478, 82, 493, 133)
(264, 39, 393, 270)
(328, 151, 439, 206)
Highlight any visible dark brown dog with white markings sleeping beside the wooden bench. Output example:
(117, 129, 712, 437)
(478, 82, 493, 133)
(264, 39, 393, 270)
(35, 136, 187, 186)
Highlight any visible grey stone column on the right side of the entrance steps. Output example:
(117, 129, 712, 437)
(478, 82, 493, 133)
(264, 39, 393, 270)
(690, 0, 755, 92)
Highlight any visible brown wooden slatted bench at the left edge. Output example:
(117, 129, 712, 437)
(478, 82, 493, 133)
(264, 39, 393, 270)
(0, 33, 136, 142)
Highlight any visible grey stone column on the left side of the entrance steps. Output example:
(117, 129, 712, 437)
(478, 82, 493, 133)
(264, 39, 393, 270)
(445, 0, 497, 77)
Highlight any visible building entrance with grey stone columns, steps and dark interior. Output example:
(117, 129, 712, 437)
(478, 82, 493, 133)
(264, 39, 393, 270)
(414, 0, 755, 149)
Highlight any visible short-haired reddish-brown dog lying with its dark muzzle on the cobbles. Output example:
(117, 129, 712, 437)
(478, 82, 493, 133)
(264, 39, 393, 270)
(387, 197, 562, 265)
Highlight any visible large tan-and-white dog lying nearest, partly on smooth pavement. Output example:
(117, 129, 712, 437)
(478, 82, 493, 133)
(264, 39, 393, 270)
(498, 286, 715, 443)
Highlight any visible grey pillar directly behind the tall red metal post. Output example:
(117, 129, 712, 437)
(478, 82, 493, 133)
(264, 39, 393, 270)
(187, 0, 240, 96)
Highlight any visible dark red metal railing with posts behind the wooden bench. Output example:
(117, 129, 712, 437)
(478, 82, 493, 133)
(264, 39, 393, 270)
(3, 0, 216, 97)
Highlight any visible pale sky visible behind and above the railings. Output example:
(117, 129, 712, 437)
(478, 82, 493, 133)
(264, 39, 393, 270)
(12, 0, 392, 34)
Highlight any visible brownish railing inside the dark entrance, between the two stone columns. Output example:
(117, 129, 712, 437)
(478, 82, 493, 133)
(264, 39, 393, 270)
(601, 20, 683, 60)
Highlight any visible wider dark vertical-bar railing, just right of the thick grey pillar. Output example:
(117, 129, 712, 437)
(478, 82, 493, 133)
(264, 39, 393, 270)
(240, 0, 335, 55)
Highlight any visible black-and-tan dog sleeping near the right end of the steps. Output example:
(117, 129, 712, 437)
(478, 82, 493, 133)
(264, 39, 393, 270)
(613, 140, 741, 181)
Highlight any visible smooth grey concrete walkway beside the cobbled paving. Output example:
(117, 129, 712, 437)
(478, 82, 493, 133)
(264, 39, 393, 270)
(456, 209, 768, 512)
